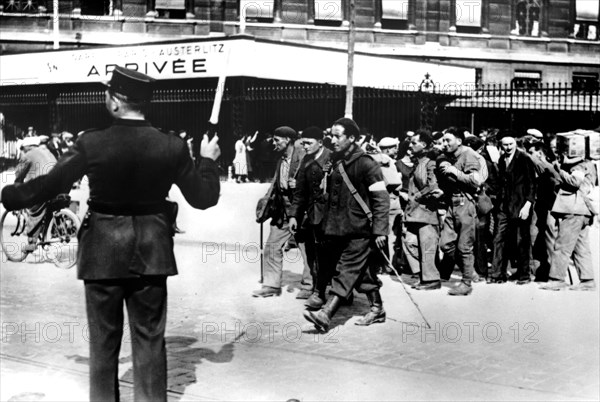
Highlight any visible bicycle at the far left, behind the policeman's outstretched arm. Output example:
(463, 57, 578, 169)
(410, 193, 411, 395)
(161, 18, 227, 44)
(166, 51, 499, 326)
(0, 194, 81, 269)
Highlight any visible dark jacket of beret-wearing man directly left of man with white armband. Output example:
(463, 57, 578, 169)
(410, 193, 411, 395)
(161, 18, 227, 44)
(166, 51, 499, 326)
(290, 148, 331, 225)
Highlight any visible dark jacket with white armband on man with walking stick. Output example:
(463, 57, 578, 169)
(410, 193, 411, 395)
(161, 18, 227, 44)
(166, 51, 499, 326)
(322, 145, 390, 238)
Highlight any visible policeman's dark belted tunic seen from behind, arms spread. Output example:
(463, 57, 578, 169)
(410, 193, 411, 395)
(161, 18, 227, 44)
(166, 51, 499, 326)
(2, 120, 220, 279)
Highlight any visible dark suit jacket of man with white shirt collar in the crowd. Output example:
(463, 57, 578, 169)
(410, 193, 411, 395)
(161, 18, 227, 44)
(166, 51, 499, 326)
(498, 149, 536, 219)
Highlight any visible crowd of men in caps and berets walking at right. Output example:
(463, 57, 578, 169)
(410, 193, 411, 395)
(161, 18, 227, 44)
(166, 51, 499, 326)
(253, 118, 597, 331)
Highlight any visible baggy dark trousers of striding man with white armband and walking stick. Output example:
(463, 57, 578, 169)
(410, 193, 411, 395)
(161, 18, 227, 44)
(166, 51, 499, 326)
(318, 236, 381, 299)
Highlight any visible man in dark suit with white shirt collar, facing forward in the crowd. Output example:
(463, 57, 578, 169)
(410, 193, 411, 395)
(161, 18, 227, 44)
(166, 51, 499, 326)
(490, 130, 536, 285)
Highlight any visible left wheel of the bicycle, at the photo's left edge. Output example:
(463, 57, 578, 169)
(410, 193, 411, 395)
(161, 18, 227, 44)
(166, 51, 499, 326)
(0, 210, 29, 262)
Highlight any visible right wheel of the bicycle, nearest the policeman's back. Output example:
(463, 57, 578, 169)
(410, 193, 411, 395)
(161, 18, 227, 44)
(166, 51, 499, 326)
(43, 208, 81, 269)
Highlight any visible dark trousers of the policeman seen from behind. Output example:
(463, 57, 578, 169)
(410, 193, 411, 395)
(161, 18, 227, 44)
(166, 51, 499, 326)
(85, 276, 167, 401)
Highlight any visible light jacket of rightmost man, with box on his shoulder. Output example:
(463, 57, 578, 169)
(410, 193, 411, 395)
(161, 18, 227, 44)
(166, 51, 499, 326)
(552, 161, 596, 216)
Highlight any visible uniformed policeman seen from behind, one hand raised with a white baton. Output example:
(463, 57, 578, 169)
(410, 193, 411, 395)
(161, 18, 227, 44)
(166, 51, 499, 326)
(2, 67, 220, 401)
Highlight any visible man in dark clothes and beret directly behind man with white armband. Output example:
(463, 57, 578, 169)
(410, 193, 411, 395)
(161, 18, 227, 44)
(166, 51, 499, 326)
(289, 127, 331, 310)
